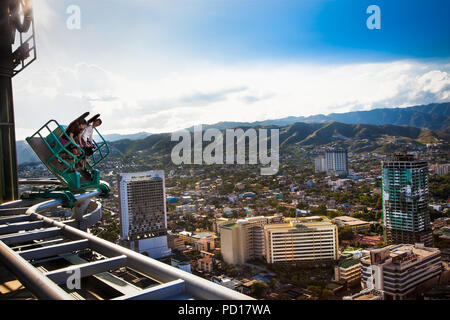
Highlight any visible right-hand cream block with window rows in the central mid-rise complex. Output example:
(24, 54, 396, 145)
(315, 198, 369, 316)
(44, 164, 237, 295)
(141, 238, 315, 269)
(264, 216, 338, 263)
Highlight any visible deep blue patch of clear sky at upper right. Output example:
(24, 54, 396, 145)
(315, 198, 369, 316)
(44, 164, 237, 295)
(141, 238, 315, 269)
(175, 0, 450, 63)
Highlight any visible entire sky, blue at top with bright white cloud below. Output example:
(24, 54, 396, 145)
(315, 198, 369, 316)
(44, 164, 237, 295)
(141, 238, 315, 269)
(15, 0, 450, 137)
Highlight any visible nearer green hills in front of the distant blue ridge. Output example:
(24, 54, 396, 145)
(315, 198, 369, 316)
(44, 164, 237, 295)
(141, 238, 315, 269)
(111, 121, 450, 156)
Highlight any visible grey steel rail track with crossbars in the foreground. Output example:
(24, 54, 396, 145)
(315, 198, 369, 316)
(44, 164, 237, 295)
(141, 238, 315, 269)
(0, 189, 251, 300)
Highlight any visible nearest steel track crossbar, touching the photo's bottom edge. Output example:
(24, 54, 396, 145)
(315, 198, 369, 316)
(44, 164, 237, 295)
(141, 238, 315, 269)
(113, 279, 186, 300)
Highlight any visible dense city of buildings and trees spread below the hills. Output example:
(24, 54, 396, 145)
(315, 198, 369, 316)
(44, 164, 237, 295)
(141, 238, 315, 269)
(20, 136, 450, 300)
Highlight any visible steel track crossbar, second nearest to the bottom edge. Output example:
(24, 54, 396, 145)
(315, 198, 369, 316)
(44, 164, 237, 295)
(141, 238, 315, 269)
(45, 255, 127, 284)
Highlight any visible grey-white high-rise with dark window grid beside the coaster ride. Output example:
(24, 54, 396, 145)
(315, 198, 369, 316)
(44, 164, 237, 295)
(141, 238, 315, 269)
(119, 171, 170, 258)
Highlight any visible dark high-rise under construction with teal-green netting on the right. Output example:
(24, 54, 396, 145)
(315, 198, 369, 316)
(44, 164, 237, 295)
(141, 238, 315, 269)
(382, 154, 433, 247)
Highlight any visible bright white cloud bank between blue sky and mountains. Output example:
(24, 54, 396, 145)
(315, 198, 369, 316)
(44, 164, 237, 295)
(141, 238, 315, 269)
(15, 61, 450, 139)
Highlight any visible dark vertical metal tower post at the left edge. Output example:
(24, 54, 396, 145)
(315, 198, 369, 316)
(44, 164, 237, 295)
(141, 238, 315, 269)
(0, 0, 36, 203)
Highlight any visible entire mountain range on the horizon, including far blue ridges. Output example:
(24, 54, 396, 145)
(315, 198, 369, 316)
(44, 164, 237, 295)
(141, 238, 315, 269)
(17, 102, 450, 164)
